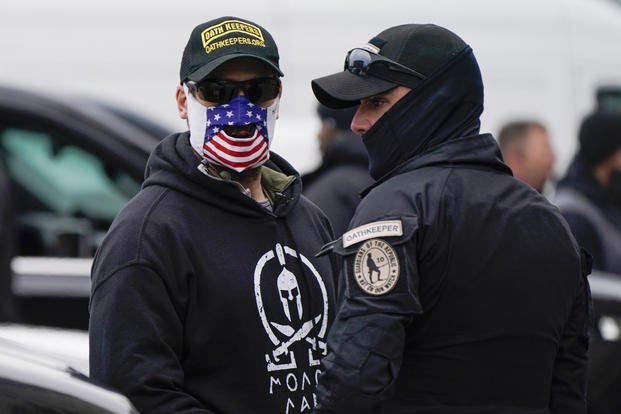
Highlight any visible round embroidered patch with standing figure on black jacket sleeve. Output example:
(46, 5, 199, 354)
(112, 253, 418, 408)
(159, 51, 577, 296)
(354, 239, 399, 295)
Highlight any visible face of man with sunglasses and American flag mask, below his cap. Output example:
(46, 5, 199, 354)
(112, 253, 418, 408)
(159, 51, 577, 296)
(182, 57, 281, 198)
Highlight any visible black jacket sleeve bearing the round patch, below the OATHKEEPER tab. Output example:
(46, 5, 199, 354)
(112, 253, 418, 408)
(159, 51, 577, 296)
(315, 218, 422, 413)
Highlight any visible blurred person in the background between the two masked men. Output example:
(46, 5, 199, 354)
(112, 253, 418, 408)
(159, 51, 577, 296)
(302, 104, 373, 236)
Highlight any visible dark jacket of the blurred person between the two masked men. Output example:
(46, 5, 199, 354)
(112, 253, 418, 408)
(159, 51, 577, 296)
(302, 133, 373, 236)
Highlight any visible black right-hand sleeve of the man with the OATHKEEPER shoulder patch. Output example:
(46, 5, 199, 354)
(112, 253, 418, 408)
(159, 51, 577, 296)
(550, 250, 592, 414)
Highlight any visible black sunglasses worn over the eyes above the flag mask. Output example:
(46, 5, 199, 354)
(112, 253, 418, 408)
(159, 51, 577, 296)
(188, 78, 280, 104)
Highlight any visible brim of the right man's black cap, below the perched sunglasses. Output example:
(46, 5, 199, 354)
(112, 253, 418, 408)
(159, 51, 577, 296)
(311, 70, 397, 108)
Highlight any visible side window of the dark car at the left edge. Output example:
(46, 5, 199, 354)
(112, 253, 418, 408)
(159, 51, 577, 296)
(0, 128, 140, 256)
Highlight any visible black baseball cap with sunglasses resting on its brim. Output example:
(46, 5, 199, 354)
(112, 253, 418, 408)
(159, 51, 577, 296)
(311, 24, 469, 108)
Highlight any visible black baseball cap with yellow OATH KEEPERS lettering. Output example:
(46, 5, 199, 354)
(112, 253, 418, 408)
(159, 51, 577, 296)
(180, 16, 283, 83)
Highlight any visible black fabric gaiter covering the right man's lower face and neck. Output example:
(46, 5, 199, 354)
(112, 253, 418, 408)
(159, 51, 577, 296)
(362, 47, 483, 180)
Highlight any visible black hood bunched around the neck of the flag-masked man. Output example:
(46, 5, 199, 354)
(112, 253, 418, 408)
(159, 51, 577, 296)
(142, 132, 301, 217)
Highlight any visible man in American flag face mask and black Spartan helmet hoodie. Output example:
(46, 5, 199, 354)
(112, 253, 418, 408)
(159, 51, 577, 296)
(89, 16, 337, 414)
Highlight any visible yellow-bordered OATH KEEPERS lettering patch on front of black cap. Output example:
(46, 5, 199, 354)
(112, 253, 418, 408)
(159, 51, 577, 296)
(201, 20, 265, 53)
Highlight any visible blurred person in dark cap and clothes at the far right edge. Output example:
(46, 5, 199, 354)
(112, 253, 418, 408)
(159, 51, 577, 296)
(555, 106, 621, 414)
